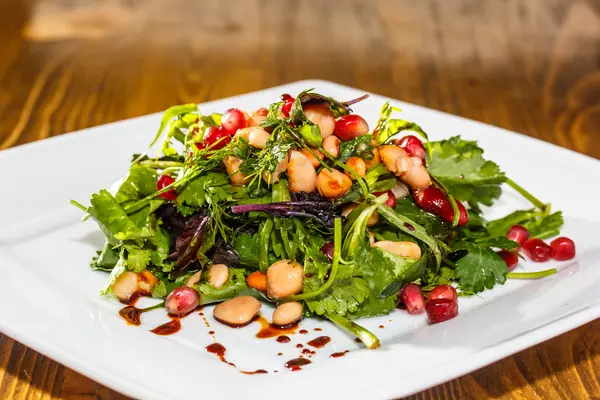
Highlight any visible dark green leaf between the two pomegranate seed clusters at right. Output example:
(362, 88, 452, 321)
(453, 241, 508, 293)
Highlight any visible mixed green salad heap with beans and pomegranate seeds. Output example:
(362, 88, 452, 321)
(72, 89, 575, 349)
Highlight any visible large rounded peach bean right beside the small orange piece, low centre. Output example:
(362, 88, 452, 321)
(267, 260, 304, 299)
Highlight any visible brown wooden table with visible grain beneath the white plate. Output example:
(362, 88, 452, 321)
(0, 0, 600, 399)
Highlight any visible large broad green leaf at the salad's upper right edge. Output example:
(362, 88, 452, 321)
(427, 136, 506, 206)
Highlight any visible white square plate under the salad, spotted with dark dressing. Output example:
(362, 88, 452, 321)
(0, 81, 600, 399)
